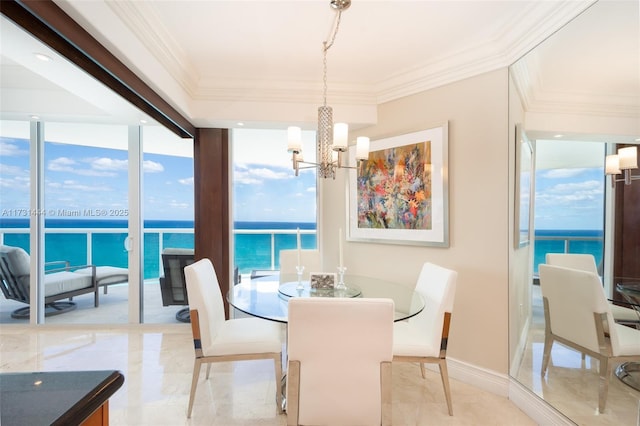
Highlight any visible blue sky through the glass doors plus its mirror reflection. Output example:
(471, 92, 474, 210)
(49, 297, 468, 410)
(0, 130, 605, 229)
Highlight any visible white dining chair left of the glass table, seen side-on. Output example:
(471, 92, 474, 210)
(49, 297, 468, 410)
(184, 259, 282, 417)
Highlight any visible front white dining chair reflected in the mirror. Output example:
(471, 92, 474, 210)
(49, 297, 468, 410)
(538, 264, 640, 413)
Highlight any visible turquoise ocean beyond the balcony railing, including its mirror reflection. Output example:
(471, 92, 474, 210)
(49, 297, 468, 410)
(0, 218, 603, 279)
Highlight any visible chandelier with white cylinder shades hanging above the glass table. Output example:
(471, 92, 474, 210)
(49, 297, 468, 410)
(287, 0, 369, 179)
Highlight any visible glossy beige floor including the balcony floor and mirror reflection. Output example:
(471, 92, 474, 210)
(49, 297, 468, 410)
(0, 284, 640, 426)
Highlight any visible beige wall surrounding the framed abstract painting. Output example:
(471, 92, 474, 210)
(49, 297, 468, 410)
(320, 68, 512, 375)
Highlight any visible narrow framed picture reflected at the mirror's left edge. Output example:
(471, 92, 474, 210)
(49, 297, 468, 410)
(514, 124, 534, 248)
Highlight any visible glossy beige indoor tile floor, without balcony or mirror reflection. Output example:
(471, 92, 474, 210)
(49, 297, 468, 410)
(0, 324, 535, 426)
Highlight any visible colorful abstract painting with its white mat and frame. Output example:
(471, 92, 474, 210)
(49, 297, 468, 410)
(347, 123, 449, 247)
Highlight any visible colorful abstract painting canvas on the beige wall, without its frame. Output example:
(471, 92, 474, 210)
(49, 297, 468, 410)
(357, 141, 432, 230)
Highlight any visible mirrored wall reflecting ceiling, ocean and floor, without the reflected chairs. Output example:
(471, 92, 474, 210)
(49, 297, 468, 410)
(509, 0, 640, 425)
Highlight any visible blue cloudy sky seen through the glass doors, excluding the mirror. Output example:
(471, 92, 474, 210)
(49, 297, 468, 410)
(0, 131, 316, 222)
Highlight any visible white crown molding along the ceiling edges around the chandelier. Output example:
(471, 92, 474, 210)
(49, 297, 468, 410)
(107, 0, 595, 111)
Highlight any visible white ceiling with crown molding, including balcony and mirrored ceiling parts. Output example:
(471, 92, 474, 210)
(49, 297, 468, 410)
(1, 0, 640, 133)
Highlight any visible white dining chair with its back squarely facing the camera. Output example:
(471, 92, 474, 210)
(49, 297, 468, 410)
(287, 297, 394, 426)
